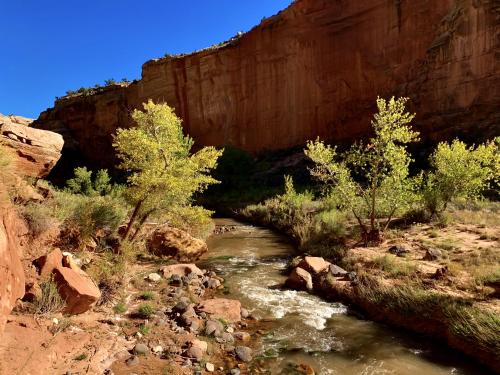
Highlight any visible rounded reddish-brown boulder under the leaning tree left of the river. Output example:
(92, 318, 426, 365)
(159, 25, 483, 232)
(147, 226, 208, 262)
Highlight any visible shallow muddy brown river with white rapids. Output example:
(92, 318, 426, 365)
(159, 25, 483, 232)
(202, 219, 488, 375)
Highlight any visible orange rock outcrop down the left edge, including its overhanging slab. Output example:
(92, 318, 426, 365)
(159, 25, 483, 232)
(0, 120, 63, 335)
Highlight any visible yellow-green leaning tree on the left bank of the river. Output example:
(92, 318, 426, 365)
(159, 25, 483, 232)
(113, 100, 222, 240)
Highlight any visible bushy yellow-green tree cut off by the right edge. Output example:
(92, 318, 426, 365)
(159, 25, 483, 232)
(422, 140, 500, 216)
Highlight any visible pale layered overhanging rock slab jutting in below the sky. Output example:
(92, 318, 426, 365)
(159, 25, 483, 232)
(0, 114, 64, 177)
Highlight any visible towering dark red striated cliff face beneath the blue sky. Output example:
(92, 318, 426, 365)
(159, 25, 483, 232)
(36, 0, 500, 167)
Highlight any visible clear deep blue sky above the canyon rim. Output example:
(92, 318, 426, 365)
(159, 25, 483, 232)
(0, 0, 291, 118)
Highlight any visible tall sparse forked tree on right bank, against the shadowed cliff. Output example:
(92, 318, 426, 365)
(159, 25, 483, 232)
(305, 97, 418, 244)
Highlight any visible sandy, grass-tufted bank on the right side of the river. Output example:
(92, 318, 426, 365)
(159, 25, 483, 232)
(238, 211, 500, 373)
